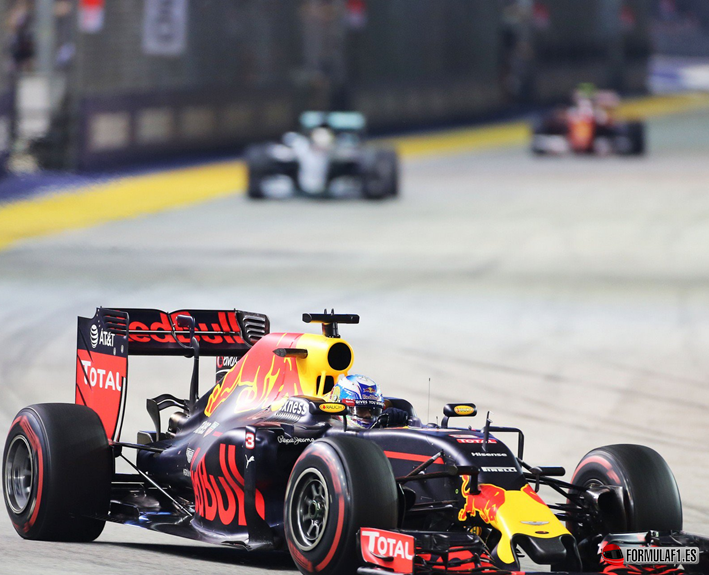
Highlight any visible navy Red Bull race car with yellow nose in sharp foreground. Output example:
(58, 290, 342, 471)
(3, 308, 709, 575)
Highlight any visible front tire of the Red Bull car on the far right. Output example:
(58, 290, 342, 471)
(571, 444, 682, 533)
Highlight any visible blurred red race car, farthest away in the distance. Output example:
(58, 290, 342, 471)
(532, 89, 645, 156)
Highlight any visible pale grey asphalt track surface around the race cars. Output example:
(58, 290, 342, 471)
(0, 107, 709, 574)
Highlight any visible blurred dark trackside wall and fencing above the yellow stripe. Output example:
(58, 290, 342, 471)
(0, 0, 709, 170)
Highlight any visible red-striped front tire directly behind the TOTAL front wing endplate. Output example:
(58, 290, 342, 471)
(284, 435, 398, 575)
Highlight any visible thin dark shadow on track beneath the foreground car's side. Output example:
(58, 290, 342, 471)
(92, 541, 298, 572)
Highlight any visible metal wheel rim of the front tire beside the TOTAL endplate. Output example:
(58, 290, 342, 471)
(291, 467, 330, 551)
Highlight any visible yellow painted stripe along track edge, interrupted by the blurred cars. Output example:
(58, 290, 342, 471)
(0, 94, 709, 250)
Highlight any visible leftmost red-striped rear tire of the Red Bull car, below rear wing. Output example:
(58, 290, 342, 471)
(2, 403, 114, 542)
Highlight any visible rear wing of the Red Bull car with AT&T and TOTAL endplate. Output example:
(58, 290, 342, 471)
(75, 308, 270, 441)
